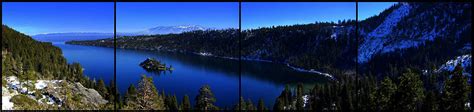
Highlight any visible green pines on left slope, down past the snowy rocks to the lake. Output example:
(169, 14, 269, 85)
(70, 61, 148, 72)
(2, 25, 118, 109)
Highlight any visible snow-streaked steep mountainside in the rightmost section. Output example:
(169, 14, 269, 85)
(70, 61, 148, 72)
(357, 3, 471, 63)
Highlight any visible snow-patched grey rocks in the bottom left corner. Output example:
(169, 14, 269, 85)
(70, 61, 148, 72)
(2, 76, 107, 110)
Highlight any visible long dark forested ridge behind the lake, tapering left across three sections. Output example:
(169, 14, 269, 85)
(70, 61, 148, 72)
(67, 20, 356, 73)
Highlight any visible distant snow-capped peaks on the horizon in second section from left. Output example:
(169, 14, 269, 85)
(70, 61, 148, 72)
(135, 25, 208, 35)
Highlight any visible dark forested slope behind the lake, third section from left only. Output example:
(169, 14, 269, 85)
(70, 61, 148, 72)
(241, 21, 356, 74)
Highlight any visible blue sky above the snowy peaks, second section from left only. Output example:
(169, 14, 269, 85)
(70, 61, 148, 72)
(117, 2, 239, 32)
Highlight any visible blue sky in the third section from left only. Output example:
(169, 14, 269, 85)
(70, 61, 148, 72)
(242, 2, 356, 30)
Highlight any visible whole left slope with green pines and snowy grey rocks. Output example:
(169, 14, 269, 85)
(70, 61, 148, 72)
(2, 25, 107, 110)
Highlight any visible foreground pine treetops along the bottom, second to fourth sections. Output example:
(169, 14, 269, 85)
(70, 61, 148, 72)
(109, 62, 471, 112)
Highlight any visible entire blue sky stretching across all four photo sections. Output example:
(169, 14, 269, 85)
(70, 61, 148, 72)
(2, 2, 395, 35)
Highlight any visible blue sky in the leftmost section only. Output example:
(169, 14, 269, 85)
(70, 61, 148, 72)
(2, 2, 114, 35)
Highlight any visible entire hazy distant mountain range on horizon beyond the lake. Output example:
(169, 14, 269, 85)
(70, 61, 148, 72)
(32, 25, 210, 42)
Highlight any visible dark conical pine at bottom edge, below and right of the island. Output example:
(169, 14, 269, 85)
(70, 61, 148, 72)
(195, 85, 218, 111)
